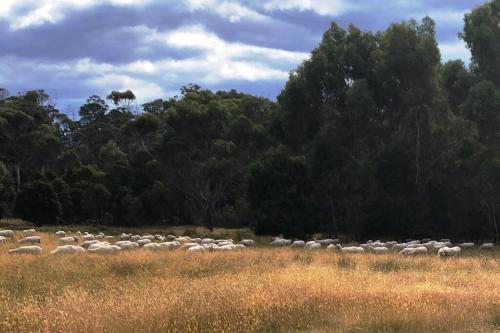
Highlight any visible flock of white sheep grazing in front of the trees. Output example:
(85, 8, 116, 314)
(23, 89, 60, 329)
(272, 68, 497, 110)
(0, 229, 495, 257)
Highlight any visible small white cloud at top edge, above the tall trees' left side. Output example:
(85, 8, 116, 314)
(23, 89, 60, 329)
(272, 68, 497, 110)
(263, 0, 356, 16)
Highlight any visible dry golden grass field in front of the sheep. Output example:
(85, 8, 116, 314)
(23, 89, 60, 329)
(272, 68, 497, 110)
(0, 234, 500, 333)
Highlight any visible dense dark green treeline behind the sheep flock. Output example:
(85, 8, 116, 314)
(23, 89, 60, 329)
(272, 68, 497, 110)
(0, 0, 500, 241)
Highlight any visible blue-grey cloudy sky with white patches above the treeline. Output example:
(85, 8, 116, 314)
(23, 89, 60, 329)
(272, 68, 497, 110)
(0, 0, 484, 112)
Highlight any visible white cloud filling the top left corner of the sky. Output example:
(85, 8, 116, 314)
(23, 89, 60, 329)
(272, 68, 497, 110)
(0, 0, 154, 30)
